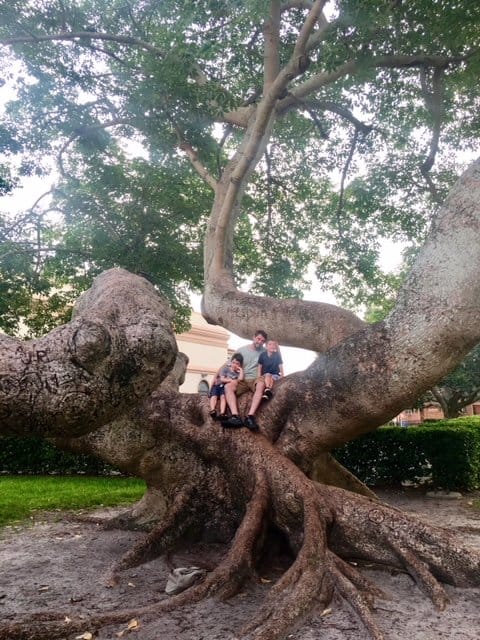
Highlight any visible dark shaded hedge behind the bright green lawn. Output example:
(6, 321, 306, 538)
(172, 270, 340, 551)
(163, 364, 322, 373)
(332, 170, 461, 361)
(0, 436, 117, 475)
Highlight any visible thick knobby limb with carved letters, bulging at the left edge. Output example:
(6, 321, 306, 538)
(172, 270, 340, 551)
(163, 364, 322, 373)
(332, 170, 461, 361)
(0, 269, 177, 436)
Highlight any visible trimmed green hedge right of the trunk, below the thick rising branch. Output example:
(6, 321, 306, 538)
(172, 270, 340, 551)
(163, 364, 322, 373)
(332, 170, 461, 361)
(332, 416, 480, 491)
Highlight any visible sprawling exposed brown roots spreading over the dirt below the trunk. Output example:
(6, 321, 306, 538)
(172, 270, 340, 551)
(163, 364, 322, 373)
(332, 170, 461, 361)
(0, 458, 480, 640)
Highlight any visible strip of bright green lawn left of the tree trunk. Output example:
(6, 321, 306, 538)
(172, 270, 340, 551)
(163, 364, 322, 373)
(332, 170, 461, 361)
(0, 476, 145, 527)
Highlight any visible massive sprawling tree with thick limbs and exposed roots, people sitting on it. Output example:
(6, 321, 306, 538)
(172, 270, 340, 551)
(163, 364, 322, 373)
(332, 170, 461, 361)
(0, 0, 480, 640)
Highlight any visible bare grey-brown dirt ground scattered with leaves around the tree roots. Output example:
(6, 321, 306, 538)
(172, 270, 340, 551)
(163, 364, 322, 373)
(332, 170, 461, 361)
(0, 489, 480, 640)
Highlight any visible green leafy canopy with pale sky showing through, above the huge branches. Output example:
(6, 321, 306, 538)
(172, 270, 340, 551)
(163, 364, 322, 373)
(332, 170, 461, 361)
(0, 0, 480, 334)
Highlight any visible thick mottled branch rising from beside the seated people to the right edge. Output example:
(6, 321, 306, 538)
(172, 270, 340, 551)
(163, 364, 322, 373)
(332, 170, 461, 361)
(272, 161, 480, 461)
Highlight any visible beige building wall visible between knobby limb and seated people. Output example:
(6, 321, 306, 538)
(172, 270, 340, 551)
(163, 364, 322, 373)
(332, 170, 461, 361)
(176, 311, 230, 393)
